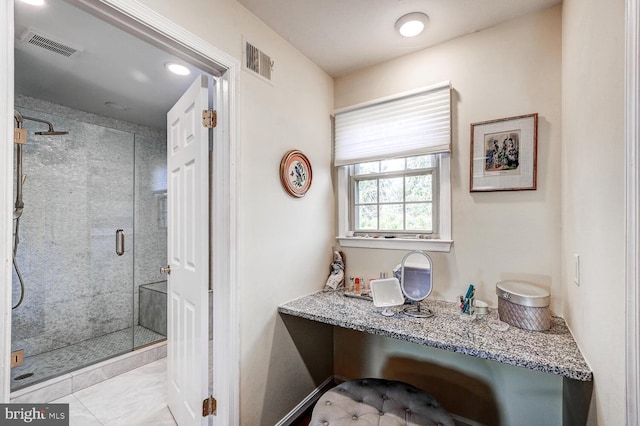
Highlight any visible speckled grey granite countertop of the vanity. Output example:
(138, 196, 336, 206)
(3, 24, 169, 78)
(278, 292, 593, 381)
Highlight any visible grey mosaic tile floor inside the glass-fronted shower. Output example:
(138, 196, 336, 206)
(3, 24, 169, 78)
(11, 326, 165, 391)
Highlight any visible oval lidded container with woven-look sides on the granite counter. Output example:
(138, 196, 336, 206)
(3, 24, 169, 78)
(496, 281, 551, 331)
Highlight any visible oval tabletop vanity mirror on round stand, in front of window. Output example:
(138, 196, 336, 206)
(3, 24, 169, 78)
(400, 250, 433, 318)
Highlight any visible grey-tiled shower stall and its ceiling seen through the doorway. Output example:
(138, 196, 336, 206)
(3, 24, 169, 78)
(11, 0, 212, 391)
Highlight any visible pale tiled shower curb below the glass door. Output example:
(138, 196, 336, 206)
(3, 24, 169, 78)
(10, 340, 167, 403)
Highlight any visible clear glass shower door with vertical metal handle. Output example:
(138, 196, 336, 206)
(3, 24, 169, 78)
(11, 105, 135, 390)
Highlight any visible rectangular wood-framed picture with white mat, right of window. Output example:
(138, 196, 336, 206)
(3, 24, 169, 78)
(469, 113, 538, 192)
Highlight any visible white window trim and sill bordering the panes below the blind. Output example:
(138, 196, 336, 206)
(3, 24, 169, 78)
(336, 153, 453, 253)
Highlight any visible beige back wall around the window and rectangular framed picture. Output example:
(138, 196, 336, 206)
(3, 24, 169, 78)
(335, 6, 563, 425)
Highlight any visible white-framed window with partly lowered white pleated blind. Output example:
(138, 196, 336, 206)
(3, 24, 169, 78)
(334, 82, 452, 251)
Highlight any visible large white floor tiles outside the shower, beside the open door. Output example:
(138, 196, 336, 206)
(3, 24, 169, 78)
(51, 358, 176, 426)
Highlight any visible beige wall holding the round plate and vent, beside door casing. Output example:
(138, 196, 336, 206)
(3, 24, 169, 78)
(135, 0, 334, 426)
